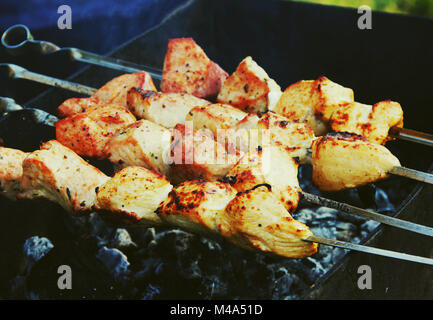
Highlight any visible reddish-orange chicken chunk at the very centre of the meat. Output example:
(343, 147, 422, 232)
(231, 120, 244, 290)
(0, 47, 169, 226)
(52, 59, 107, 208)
(171, 124, 240, 184)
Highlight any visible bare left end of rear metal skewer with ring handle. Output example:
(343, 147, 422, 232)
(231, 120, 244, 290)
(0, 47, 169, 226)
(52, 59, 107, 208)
(1, 24, 162, 80)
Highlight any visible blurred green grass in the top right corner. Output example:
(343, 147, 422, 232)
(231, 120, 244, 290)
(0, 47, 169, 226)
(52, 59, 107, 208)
(295, 0, 433, 17)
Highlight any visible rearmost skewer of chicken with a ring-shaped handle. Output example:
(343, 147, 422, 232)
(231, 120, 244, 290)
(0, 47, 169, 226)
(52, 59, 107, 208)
(2, 30, 433, 146)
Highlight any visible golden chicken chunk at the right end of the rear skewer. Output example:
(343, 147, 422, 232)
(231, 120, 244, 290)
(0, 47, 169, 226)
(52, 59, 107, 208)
(329, 101, 403, 144)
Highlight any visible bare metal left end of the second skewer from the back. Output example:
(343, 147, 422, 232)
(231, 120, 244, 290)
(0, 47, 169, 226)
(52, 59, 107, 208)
(0, 63, 96, 96)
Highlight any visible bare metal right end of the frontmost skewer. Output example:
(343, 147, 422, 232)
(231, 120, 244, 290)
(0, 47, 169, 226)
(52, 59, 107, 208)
(303, 236, 433, 266)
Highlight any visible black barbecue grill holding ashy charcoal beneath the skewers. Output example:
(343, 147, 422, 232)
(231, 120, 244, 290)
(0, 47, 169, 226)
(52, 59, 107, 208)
(2, 1, 433, 299)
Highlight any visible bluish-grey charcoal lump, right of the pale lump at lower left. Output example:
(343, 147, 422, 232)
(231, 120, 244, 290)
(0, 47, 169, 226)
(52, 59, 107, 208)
(96, 246, 130, 280)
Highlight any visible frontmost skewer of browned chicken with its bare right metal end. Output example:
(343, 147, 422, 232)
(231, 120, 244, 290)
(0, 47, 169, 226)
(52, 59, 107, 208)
(0, 140, 433, 265)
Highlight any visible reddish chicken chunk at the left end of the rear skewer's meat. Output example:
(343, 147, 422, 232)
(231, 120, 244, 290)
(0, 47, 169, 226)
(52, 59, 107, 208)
(161, 38, 228, 98)
